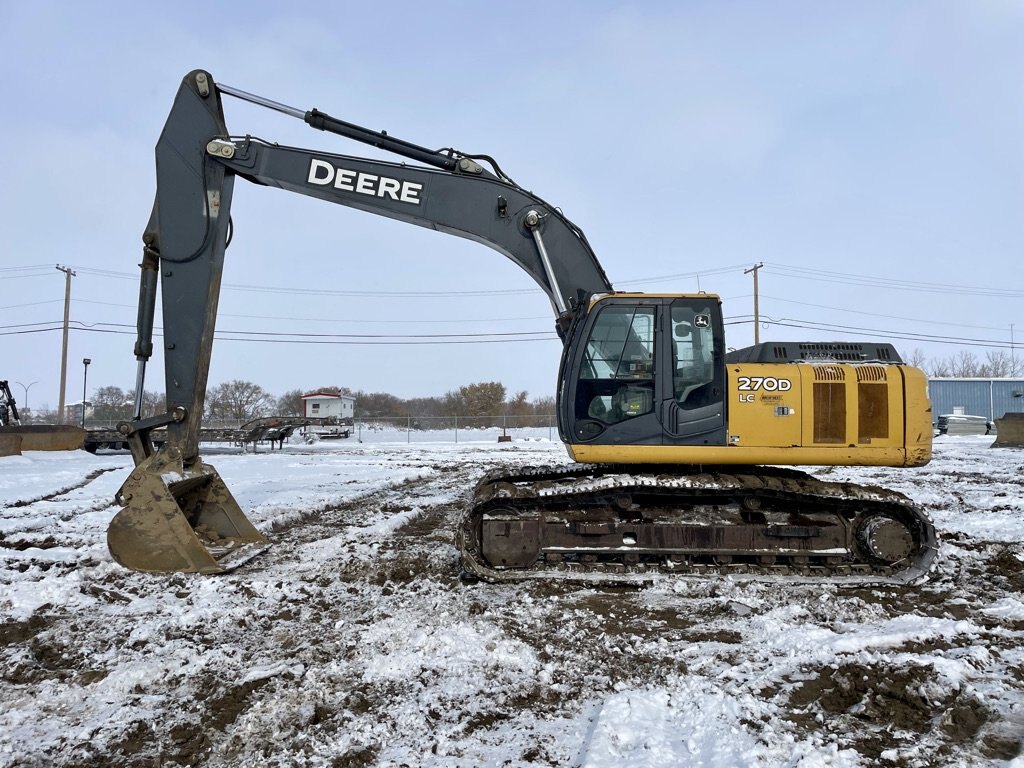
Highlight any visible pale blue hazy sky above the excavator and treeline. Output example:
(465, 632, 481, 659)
(0, 0, 1024, 410)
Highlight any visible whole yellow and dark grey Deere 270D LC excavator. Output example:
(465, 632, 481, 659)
(108, 70, 938, 584)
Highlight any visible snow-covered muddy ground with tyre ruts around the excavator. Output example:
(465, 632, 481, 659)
(0, 429, 1024, 768)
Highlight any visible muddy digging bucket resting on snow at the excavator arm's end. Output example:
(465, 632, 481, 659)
(106, 450, 267, 573)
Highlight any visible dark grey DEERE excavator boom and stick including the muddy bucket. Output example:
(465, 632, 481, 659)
(108, 70, 612, 572)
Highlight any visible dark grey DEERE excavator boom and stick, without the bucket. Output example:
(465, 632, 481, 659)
(135, 71, 612, 466)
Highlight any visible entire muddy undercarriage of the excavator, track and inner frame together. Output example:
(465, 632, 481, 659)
(459, 465, 938, 584)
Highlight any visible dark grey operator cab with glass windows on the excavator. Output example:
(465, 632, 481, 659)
(559, 294, 726, 445)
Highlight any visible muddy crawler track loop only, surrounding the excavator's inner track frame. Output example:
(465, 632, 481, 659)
(458, 465, 938, 586)
